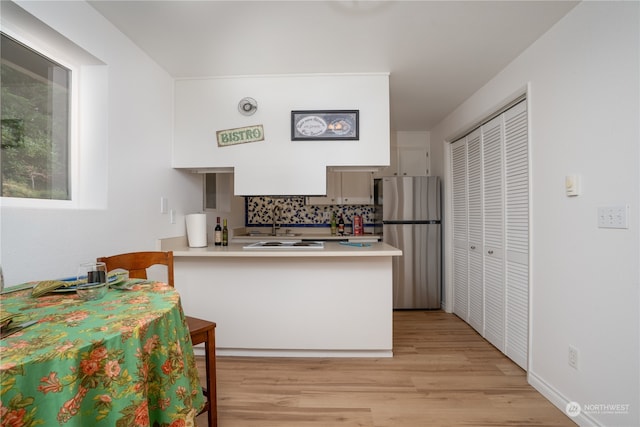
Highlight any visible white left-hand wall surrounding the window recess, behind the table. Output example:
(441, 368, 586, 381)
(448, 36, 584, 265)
(0, 1, 202, 285)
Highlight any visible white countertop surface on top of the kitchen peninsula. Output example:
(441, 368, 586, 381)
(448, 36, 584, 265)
(158, 237, 402, 258)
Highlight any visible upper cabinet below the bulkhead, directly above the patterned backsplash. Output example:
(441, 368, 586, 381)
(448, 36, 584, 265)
(306, 171, 373, 205)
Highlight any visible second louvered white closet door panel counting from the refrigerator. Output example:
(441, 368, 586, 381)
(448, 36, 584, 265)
(466, 130, 484, 335)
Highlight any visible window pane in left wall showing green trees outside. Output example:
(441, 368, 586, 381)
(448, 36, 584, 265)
(0, 34, 71, 200)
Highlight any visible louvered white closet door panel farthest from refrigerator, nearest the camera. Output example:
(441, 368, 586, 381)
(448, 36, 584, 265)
(504, 101, 529, 369)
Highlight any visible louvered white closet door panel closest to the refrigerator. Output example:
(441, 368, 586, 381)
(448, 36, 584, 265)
(451, 138, 469, 322)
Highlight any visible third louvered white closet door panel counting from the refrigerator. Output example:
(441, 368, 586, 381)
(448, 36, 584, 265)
(480, 116, 505, 352)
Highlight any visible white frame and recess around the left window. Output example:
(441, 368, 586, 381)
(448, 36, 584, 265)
(0, 2, 107, 209)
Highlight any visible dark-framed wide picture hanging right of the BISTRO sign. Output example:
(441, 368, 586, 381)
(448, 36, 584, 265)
(291, 110, 360, 141)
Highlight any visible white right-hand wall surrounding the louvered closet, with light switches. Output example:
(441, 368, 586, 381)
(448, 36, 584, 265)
(431, 2, 640, 426)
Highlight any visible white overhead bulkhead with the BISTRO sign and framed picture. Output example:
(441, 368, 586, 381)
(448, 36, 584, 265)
(173, 72, 390, 196)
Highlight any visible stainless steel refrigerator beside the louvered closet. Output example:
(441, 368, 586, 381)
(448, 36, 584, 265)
(377, 177, 442, 309)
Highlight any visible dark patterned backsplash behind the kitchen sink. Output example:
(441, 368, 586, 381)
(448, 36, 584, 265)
(245, 196, 374, 231)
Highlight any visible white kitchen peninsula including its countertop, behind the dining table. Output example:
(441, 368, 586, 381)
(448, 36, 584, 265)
(158, 237, 402, 357)
